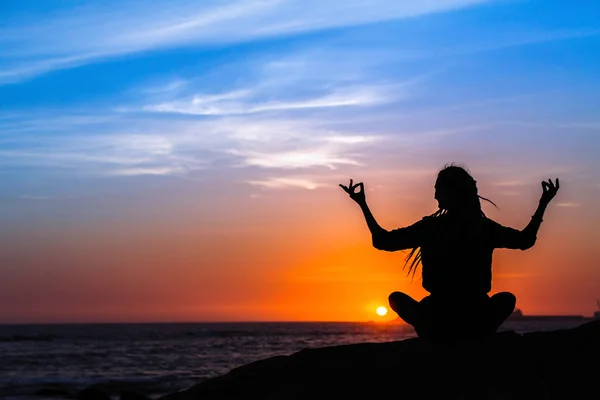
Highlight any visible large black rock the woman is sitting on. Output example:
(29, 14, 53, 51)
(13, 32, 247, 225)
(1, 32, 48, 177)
(159, 321, 600, 400)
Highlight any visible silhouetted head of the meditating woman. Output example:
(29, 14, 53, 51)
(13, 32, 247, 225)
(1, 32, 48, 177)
(435, 165, 481, 211)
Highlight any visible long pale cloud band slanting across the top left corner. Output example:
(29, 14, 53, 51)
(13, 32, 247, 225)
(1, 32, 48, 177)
(0, 0, 486, 83)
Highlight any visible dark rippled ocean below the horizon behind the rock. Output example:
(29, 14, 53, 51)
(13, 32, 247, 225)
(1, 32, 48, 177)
(0, 320, 582, 400)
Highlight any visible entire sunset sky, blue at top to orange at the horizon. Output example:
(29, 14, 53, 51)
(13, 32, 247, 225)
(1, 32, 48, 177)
(0, 0, 600, 323)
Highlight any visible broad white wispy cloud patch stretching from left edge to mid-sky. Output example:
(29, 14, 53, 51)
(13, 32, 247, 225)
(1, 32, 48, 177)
(0, 42, 398, 177)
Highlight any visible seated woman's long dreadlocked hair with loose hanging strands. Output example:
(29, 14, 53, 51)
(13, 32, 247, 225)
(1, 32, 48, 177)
(402, 164, 498, 278)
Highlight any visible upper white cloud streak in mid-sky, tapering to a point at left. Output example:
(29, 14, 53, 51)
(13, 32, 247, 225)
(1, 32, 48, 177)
(135, 43, 418, 116)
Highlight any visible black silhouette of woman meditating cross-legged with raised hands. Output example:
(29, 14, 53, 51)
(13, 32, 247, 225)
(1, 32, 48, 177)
(340, 165, 559, 340)
